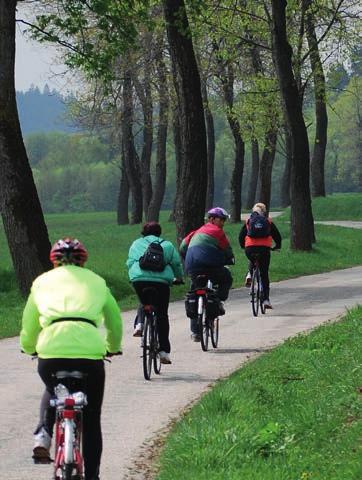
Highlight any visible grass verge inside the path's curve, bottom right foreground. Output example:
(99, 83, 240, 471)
(156, 307, 362, 480)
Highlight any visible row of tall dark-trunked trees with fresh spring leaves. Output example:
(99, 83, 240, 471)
(0, 0, 357, 294)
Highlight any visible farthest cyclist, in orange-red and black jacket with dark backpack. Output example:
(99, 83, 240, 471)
(239, 203, 282, 308)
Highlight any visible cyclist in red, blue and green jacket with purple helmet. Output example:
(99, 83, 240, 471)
(180, 207, 235, 341)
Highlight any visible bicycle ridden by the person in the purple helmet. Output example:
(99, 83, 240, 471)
(195, 275, 219, 352)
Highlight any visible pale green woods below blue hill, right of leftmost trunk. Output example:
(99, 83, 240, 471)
(25, 132, 120, 212)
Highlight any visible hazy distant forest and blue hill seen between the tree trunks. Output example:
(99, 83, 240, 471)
(17, 73, 362, 213)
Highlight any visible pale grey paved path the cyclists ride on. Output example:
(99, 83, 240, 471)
(0, 266, 362, 480)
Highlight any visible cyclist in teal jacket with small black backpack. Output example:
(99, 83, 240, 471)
(127, 222, 183, 364)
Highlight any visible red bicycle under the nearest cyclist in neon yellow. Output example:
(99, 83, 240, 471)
(50, 370, 87, 480)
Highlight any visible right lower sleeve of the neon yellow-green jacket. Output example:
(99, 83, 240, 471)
(103, 289, 123, 353)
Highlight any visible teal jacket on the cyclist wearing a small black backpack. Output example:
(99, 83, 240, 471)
(126, 235, 183, 285)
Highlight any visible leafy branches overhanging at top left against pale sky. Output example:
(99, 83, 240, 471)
(31, 0, 151, 81)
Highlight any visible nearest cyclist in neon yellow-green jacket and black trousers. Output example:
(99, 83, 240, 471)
(20, 238, 122, 480)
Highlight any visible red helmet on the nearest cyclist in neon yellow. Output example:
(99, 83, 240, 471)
(50, 237, 88, 267)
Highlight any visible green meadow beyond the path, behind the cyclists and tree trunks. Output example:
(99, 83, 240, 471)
(0, 195, 362, 338)
